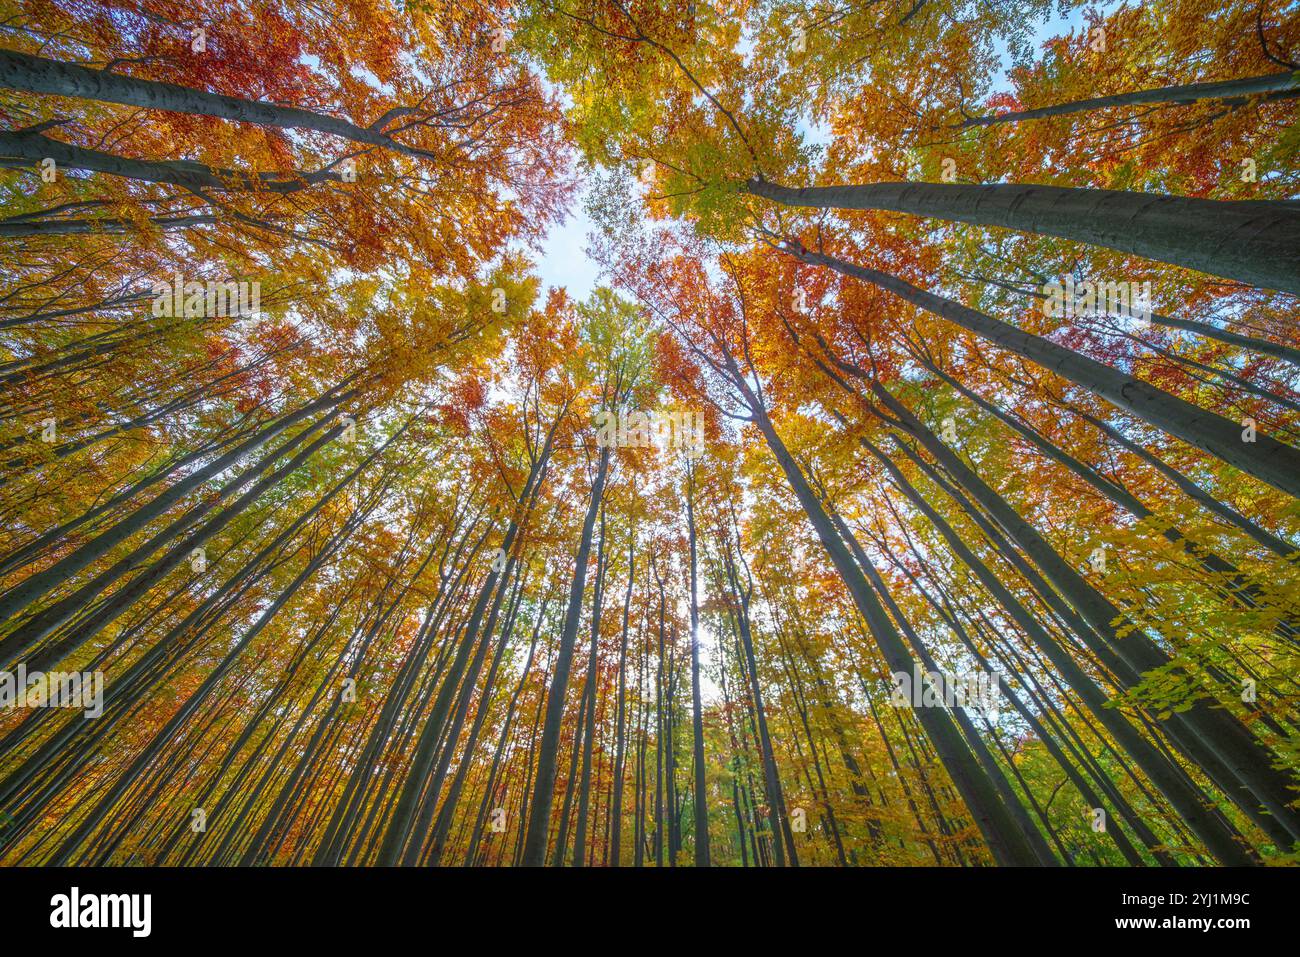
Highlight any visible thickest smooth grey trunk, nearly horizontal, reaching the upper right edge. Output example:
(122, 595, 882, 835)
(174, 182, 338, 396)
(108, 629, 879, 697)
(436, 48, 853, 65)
(744, 179, 1300, 294)
